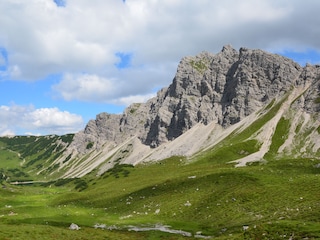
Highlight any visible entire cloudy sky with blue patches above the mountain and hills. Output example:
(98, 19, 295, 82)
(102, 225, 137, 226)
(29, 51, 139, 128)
(0, 0, 320, 136)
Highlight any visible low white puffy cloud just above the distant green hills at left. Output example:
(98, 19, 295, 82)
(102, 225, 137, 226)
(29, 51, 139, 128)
(0, 105, 83, 136)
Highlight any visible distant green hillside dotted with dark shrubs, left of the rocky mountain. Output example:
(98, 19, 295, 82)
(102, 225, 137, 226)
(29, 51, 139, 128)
(0, 134, 73, 181)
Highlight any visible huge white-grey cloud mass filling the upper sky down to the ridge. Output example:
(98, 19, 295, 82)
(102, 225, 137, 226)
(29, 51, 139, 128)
(0, 0, 320, 103)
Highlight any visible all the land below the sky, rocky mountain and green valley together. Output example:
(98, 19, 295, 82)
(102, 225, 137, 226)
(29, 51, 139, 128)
(0, 45, 320, 239)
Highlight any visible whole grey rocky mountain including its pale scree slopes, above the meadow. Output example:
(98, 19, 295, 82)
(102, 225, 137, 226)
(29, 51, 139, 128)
(0, 45, 320, 178)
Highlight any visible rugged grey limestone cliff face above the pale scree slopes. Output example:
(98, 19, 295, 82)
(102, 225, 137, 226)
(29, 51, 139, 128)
(70, 46, 320, 153)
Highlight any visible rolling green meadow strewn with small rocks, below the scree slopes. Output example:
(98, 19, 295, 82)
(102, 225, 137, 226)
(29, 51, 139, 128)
(0, 155, 320, 239)
